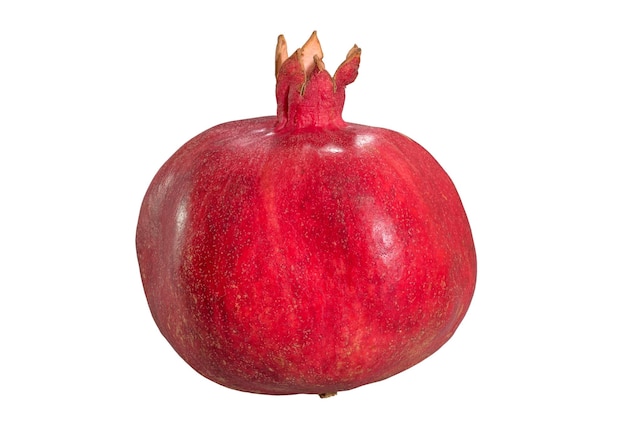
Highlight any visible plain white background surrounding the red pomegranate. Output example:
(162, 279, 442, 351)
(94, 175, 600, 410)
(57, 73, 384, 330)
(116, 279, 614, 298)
(0, 0, 626, 428)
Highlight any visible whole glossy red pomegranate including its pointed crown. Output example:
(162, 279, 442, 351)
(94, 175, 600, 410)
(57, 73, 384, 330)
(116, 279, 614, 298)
(136, 33, 476, 397)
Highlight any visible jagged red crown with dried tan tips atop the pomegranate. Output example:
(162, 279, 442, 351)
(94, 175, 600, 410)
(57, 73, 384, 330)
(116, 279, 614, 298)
(276, 31, 361, 130)
